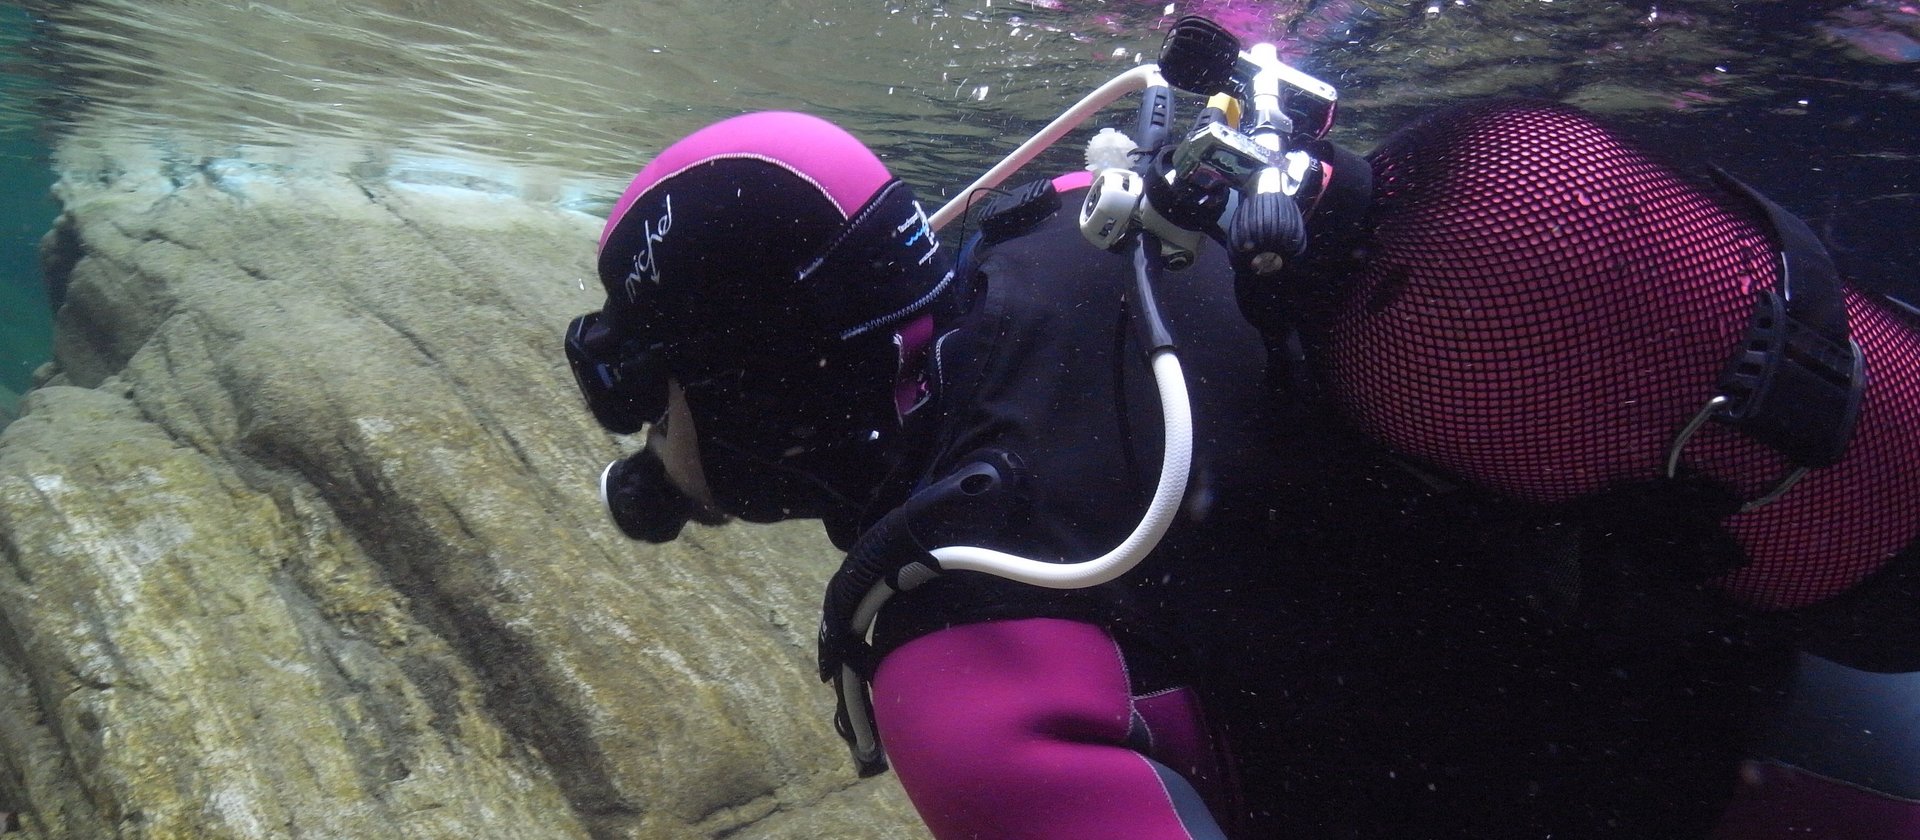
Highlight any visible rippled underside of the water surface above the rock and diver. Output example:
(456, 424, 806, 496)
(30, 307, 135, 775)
(0, 0, 1920, 391)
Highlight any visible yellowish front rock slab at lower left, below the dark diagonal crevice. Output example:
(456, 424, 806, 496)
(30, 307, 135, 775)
(0, 387, 586, 838)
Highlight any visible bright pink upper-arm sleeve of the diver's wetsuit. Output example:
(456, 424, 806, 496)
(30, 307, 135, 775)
(874, 618, 1225, 840)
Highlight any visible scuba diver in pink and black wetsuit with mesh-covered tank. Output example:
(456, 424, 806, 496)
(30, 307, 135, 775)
(566, 14, 1920, 840)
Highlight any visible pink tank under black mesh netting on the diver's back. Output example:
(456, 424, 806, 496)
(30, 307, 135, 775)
(1325, 102, 1920, 608)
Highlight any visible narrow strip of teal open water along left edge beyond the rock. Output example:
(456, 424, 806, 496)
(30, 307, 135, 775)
(0, 6, 60, 410)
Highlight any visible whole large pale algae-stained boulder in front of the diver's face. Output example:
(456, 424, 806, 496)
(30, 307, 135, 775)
(0, 147, 924, 840)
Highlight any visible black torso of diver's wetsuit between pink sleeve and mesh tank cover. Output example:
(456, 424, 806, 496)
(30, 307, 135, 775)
(856, 175, 1812, 838)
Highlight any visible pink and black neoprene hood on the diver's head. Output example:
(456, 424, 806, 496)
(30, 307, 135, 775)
(589, 111, 952, 533)
